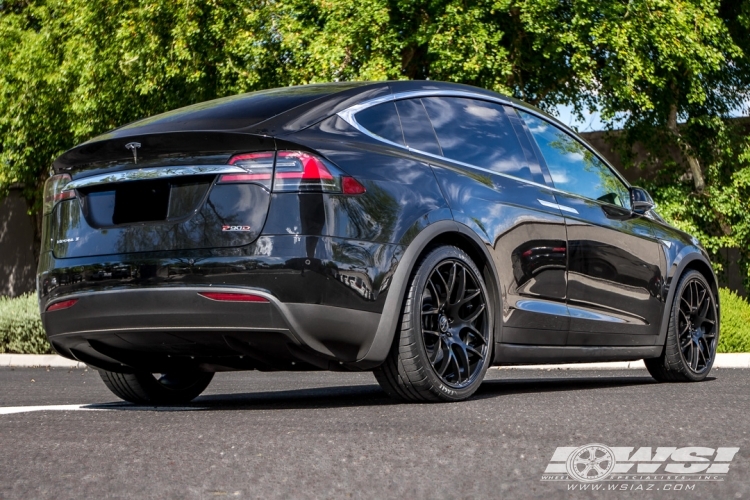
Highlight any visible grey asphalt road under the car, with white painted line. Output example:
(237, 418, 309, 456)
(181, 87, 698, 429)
(0, 368, 750, 499)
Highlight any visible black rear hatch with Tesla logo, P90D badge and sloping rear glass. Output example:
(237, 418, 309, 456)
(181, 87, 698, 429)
(44, 83, 374, 258)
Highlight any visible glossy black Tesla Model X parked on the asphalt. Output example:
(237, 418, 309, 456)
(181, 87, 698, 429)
(37, 81, 719, 404)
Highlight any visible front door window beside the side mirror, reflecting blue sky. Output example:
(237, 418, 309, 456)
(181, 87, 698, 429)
(519, 111, 630, 208)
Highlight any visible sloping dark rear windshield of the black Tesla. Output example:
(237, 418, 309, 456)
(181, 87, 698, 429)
(97, 83, 368, 140)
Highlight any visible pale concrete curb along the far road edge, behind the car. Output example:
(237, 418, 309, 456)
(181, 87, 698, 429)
(0, 352, 750, 370)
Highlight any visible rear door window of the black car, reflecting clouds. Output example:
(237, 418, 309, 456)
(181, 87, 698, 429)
(422, 97, 544, 183)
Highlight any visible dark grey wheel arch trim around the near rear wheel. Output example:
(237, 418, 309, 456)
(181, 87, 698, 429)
(356, 220, 502, 369)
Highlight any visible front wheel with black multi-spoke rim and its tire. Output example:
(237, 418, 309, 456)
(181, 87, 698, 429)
(643, 270, 719, 382)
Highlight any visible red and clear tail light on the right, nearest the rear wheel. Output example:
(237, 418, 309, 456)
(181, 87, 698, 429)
(219, 151, 365, 194)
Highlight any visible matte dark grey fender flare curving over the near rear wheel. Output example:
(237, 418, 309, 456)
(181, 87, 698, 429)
(355, 220, 501, 370)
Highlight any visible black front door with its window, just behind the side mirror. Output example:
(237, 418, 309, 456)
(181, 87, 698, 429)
(520, 112, 663, 346)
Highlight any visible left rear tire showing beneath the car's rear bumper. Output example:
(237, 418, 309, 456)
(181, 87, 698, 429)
(99, 370, 214, 405)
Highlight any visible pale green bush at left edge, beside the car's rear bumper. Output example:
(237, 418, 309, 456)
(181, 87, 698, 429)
(0, 293, 53, 354)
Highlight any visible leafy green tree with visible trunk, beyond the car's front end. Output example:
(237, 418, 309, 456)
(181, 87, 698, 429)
(522, 0, 750, 284)
